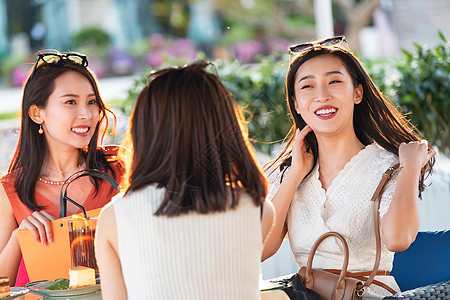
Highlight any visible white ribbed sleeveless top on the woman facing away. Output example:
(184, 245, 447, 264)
(112, 185, 262, 300)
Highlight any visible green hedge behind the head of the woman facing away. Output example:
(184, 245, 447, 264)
(118, 56, 291, 154)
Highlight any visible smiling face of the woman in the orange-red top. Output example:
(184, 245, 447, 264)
(34, 71, 100, 150)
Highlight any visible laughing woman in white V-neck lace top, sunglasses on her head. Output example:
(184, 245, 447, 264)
(263, 37, 435, 298)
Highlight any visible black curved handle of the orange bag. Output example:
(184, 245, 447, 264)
(59, 169, 119, 218)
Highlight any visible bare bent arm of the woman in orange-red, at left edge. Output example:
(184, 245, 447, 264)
(0, 184, 22, 286)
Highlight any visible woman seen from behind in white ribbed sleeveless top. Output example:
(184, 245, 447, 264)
(96, 62, 273, 300)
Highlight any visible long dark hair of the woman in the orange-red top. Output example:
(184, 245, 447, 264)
(8, 60, 116, 210)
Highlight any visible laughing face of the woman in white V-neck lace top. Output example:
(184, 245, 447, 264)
(294, 55, 363, 137)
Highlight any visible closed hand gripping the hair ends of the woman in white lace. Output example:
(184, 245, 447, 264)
(398, 140, 436, 170)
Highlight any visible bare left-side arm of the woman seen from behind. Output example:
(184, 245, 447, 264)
(95, 205, 127, 300)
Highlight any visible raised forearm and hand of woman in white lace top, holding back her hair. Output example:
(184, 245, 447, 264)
(380, 140, 436, 252)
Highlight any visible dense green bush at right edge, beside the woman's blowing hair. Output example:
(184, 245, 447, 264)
(391, 32, 450, 155)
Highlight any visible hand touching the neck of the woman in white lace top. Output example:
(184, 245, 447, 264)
(290, 125, 314, 174)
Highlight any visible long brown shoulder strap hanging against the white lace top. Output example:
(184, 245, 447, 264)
(364, 164, 400, 287)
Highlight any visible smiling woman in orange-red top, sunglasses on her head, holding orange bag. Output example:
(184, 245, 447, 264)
(0, 52, 123, 286)
